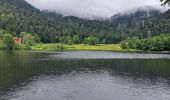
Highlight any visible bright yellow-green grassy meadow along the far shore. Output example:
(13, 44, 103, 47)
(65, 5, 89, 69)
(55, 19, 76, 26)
(32, 44, 136, 51)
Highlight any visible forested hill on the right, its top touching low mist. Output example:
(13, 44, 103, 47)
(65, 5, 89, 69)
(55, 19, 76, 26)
(112, 10, 170, 38)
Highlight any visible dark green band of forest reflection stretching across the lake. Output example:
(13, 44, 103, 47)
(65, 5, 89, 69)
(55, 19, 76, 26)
(0, 52, 170, 94)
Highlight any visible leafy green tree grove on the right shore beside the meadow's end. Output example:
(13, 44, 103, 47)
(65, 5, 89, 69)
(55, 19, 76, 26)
(121, 34, 170, 51)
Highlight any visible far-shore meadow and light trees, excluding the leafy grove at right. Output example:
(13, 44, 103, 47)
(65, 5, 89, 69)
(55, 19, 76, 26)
(0, 30, 135, 51)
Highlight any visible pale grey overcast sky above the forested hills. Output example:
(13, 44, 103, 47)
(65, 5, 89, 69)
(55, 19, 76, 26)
(26, 0, 167, 18)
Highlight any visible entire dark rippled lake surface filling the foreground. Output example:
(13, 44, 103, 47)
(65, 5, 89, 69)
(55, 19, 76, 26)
(0, 51, 170, 100)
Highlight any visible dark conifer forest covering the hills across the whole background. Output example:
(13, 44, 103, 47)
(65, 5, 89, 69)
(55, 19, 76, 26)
(0, 0, 170, 43)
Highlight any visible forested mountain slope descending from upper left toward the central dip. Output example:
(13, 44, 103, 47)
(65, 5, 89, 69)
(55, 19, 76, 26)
(0, 0, 115, 42)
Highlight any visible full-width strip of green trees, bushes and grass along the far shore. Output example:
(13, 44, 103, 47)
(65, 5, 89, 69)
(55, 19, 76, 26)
(0, 30, 170, 51)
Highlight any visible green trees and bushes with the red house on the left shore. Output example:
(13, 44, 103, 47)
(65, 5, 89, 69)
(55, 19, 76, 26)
(0, 30, 40, 50)
